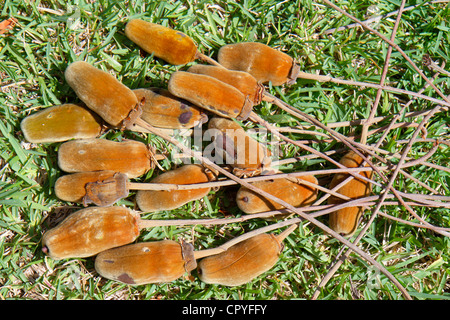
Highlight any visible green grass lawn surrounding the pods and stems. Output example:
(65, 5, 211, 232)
(0, 0, 450, 300)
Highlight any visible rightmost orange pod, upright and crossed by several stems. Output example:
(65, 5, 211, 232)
(328, 151, 372, 236)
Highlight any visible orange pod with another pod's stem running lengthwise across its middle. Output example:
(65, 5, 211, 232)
(136, 164, 214, 212)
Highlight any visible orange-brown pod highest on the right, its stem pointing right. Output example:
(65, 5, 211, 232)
(218, 42, 299, 86)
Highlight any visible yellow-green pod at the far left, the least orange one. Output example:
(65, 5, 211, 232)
(20, 103, 102, 143)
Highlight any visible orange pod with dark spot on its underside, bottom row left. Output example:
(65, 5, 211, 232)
(95, 240, 195, 285)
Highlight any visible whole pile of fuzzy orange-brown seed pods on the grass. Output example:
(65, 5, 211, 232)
(21, 19, 371, 286)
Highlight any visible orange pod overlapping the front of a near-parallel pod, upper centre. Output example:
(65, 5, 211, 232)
(168, 71, 253, 120)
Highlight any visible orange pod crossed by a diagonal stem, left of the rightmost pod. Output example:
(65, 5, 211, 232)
(236, 176, 318, 214)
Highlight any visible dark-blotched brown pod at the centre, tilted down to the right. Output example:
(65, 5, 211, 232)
(208, 117, 271, 177)
